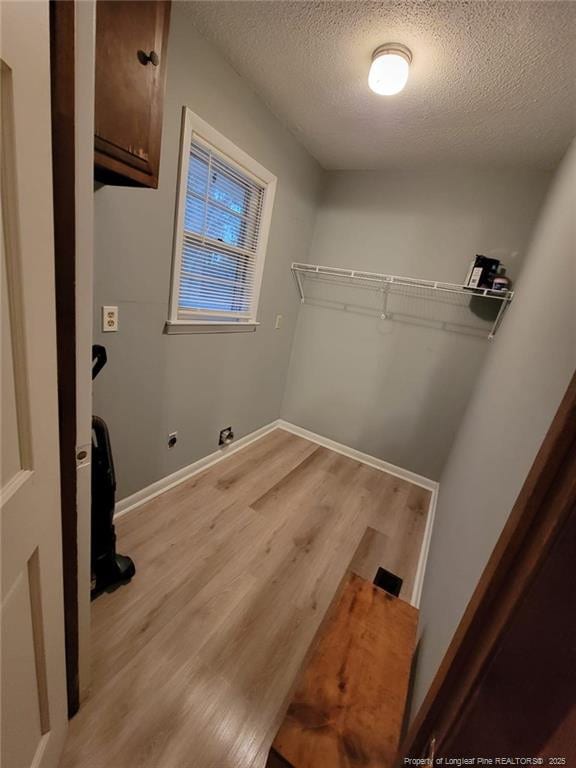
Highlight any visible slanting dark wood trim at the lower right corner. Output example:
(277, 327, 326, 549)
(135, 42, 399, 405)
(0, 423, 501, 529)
(398, 374, 576, 765)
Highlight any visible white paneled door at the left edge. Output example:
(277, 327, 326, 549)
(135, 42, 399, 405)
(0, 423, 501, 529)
(0, 0, 67, 768)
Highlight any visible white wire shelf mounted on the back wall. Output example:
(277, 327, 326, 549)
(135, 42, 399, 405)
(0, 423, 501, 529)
(292, 262, 514, 339)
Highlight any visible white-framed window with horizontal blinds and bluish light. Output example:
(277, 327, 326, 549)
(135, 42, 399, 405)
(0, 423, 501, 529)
(168, 108, 276, 332)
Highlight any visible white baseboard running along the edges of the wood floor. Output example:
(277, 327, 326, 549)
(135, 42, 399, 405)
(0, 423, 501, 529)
(114, 419, 439, 608)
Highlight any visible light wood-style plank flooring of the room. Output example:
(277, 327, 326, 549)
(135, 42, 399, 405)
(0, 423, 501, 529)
(61, 429, 430, 768)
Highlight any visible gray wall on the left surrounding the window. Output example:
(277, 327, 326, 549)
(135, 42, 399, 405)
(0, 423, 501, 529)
(94, 3, 321, 498)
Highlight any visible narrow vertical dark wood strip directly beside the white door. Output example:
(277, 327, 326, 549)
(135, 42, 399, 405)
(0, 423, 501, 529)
(50, 0, 80, 717)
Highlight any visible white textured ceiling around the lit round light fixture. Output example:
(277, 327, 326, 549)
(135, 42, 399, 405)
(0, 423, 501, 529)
(187, 0, 576, 169)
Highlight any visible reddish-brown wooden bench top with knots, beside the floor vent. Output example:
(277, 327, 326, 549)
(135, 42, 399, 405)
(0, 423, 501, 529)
(267, 574, 418, 768)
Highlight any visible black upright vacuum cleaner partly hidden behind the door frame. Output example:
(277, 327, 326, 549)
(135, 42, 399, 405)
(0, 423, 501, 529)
(91, 344, 136, 599)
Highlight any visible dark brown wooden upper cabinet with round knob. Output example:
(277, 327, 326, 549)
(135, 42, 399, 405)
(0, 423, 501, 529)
(94, 0, 170, 188)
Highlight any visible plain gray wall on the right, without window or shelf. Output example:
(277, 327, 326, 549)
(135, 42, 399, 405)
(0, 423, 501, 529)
(414, 144, 576, 707)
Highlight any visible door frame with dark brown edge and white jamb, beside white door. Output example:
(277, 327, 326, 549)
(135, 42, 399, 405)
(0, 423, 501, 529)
(50, 0, 96, 717)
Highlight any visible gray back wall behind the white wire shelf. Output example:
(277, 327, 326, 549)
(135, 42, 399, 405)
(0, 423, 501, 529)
(282, 169, 549, 479)
